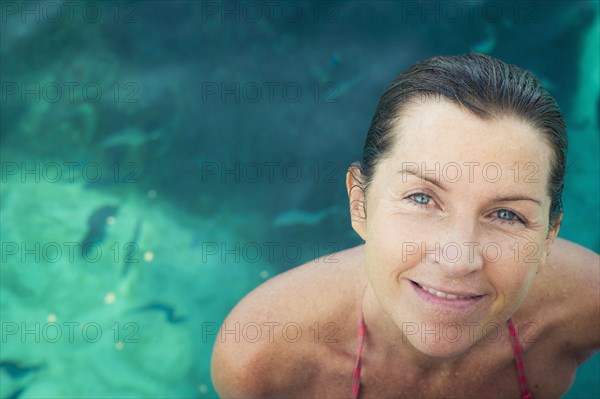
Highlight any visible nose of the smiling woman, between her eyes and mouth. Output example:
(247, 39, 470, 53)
(425, 217, 484, 277)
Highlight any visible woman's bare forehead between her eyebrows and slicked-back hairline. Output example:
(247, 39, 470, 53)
(391, 100, 551, 177)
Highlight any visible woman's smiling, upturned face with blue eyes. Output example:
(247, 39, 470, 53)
(351, 100, 557, 357)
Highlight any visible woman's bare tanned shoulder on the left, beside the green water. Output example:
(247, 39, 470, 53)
(211, 247, 364, 398)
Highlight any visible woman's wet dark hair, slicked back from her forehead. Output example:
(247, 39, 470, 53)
(353, 53, 567, 229)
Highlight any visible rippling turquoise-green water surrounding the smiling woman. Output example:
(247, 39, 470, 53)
(0, 1, 600, 398)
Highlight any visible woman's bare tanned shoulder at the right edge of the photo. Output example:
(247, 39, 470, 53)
(532, 238, 600, 363)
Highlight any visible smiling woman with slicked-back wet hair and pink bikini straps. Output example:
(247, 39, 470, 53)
(212, 54, 600, 398)
